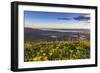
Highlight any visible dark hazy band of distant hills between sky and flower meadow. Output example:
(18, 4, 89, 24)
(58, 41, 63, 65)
(24, 28, 90, 41)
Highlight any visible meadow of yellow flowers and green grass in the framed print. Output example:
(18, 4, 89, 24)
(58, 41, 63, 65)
(24, 38, 90, 62)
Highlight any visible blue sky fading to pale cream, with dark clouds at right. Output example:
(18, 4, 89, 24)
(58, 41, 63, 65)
(24, 11, 90, 29)
